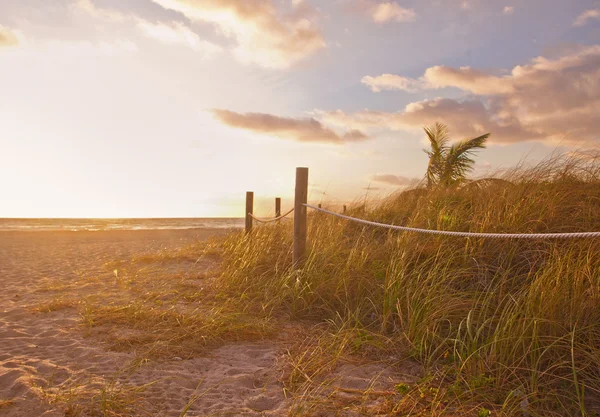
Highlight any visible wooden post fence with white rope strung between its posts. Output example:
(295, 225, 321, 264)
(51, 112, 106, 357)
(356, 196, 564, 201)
(246, 167, 600, 268)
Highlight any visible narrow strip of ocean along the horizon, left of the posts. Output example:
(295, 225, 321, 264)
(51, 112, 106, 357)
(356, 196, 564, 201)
(0, 218, 244, 232)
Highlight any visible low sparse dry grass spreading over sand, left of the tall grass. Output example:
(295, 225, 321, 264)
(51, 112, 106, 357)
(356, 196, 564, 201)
(79, 254, 272, 357)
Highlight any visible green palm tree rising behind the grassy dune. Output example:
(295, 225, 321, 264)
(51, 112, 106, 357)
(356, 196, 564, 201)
(424, 123, 490, 187)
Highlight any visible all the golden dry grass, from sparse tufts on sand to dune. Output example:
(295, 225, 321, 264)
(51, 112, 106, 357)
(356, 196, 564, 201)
(30, 156, 600, 417)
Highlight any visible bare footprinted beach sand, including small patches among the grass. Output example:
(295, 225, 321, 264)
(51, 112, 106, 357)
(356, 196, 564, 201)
(0, 229, 418, 417)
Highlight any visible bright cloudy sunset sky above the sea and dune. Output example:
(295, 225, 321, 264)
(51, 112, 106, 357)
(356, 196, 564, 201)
(0, 0, 600, 217)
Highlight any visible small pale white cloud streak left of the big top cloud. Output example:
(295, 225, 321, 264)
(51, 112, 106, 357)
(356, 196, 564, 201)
(137, 19, 222, 57)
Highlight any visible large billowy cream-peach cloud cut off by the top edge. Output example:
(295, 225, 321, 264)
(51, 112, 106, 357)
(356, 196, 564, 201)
(153, 0, 325, 69)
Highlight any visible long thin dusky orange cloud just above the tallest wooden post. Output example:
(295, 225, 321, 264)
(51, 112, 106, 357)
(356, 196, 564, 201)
(211, 109, 369, 144)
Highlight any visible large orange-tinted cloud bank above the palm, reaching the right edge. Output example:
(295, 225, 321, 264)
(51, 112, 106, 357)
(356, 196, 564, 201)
(344, 45, 600, 143)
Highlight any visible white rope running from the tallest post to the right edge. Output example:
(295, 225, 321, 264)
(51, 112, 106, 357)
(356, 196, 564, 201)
(304, 204, 600, 239)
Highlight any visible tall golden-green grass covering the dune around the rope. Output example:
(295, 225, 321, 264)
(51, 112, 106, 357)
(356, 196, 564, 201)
(222, 155, 600, 416)
